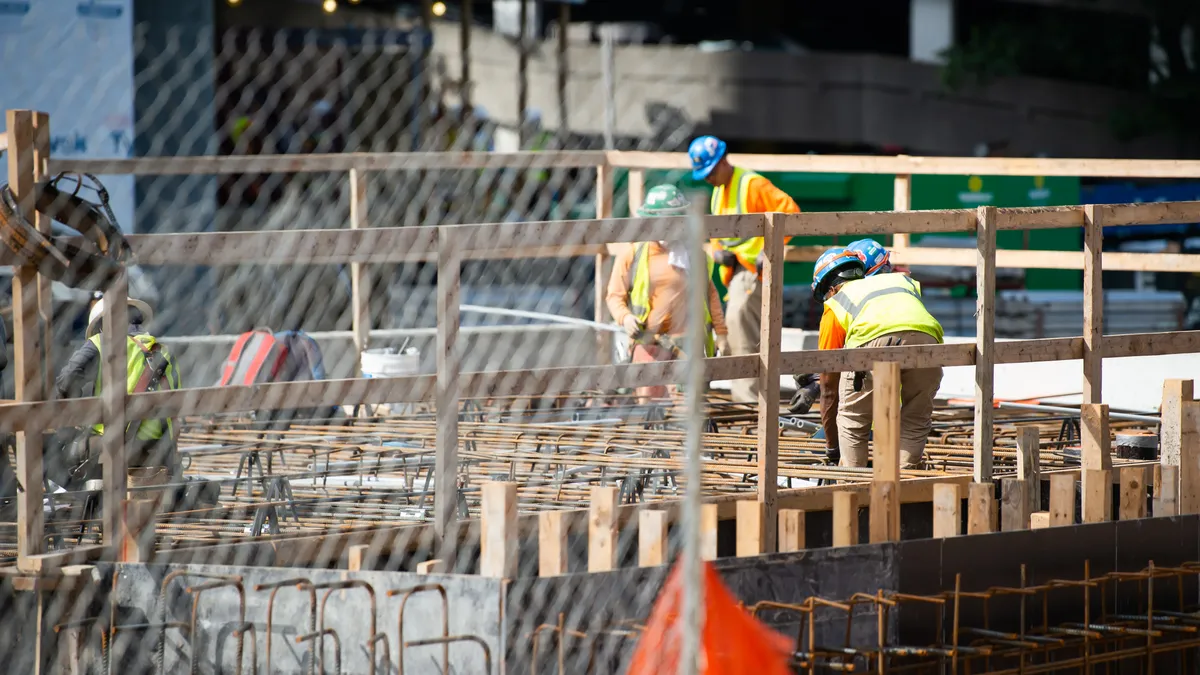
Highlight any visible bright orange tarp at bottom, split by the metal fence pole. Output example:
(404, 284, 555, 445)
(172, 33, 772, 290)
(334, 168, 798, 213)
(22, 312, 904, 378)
(629, 562, 792, 675)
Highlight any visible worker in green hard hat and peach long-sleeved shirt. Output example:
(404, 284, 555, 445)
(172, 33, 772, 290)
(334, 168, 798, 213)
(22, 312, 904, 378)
(607, 185, 730, 400)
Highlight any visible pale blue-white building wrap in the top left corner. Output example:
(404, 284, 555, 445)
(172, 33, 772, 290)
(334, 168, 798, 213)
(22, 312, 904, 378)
(0, 0, 136, 232)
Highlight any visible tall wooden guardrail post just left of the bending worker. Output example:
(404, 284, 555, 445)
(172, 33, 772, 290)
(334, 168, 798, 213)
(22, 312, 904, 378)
(757, 214, 784, 554)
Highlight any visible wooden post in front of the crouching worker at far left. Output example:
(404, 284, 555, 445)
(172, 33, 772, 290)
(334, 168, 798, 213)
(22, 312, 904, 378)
(100, 271, 130, 554)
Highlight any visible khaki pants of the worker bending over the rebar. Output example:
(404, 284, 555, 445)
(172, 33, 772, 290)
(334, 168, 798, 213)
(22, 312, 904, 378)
(838, 330, 942, 468)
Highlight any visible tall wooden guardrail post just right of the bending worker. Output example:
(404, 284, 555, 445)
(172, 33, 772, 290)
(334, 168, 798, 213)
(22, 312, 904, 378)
(974, 201, 996, 483)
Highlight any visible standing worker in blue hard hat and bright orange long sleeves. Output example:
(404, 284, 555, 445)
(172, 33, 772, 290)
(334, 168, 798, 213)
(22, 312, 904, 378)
(688, 136, 800, 402)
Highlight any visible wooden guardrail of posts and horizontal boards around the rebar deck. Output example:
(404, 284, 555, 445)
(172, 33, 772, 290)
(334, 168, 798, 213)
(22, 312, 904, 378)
(7, 110, 1200, 572)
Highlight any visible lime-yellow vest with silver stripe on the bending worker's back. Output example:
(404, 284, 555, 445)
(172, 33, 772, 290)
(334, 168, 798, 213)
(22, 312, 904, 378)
(824, 273, 942, 347)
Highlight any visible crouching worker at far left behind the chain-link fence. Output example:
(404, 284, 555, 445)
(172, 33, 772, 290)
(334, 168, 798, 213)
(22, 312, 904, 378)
(54, 298, 180, 498)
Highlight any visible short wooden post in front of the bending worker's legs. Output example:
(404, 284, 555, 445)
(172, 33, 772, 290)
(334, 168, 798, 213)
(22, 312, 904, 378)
(869, 362, 900, 544)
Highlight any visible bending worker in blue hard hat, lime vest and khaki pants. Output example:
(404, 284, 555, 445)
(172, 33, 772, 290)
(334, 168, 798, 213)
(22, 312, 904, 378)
(812, 247, 942, 468)
